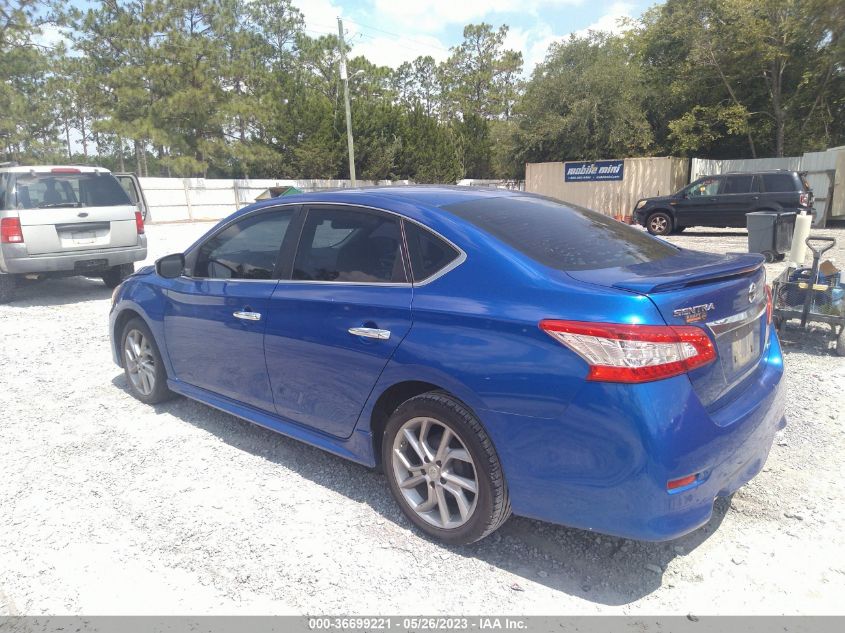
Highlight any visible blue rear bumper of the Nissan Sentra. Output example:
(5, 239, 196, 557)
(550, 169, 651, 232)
(482, 331, 786, 541)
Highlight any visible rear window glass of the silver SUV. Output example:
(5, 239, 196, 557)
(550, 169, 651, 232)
(4, 172, 132, 209)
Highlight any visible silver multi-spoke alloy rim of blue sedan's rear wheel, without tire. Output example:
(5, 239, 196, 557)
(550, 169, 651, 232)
(392, 417, 478, 529)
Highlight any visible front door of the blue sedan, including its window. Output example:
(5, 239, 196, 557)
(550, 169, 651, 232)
(164, 206, 298, 412)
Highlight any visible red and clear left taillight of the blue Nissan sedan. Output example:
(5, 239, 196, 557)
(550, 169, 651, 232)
(540, 320, 716, 383)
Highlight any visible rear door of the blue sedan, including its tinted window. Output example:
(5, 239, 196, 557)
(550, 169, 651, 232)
(265, 205, 412, 437)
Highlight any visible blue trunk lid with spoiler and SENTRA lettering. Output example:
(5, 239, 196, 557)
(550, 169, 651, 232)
(568, 249, 768, 407)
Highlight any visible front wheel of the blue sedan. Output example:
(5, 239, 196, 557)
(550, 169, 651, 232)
(120, 318, 173, 404)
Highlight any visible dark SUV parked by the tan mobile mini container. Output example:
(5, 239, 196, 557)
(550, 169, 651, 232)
(634, 169, 813, 235)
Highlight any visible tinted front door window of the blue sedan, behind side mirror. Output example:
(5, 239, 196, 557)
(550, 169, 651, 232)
(193, 210, 293, 279)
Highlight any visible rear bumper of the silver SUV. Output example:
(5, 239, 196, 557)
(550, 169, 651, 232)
(0, 236, 147, 275)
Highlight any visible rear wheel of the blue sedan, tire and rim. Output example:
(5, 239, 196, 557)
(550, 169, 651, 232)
(382, 392, 511, 544)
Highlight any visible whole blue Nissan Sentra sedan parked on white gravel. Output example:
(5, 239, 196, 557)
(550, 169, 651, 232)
(110, 187, 786, 543)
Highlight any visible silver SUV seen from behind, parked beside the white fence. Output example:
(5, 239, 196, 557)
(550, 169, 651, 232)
(0, 165, 147, 302)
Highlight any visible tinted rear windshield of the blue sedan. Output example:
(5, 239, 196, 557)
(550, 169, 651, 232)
(443, 197, 678, 270)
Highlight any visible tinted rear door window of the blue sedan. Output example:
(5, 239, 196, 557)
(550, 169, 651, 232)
(293, 207, 407, 283)
